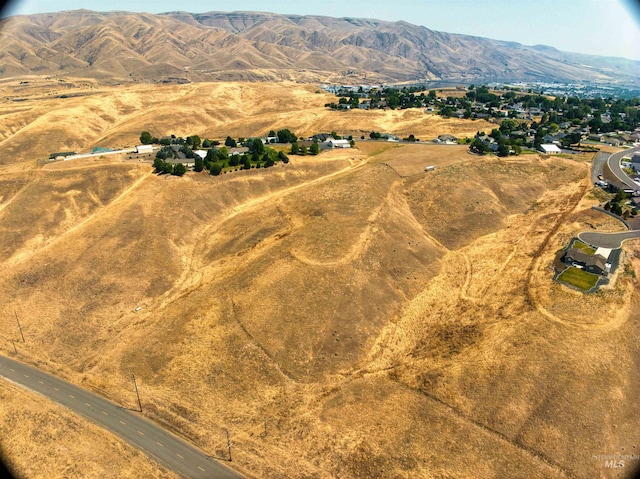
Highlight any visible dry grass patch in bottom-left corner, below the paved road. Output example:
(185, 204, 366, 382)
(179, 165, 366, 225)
(0, 381, 177, 479)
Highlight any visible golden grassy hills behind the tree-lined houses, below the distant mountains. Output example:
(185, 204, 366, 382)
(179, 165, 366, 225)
(0, 78, 494, 164)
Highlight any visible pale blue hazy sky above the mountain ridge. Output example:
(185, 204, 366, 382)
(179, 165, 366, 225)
(3, 0, 640, 60)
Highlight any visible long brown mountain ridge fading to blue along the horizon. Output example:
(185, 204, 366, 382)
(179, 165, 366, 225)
(0, 10, 640, 84)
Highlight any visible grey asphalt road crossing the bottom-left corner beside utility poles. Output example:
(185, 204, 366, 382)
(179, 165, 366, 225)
(0, 355, 244, 479)
